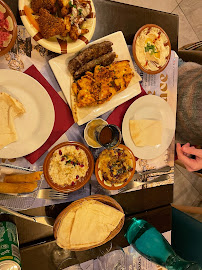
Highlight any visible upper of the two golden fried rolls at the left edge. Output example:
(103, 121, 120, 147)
(4, 171, 43, 183)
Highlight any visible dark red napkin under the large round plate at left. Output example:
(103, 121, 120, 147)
(24, 65, 74, 164)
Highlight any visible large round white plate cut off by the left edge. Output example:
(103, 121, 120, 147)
(0, 69, 55, 158)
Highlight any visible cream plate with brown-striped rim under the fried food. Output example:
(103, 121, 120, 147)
(18, 0, 96, 53)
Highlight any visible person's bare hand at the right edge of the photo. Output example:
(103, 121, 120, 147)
(176, 143, 202, 172)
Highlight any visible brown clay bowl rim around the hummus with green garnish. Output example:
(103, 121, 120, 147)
(132, 24, 171, 74)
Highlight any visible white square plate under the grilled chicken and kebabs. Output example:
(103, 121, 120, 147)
(49, 31, 141, 125)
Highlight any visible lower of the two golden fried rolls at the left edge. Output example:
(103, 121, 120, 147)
(0, 182, 37, 193)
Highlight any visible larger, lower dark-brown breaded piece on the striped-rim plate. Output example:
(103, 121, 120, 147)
(37, 8, 66, 39)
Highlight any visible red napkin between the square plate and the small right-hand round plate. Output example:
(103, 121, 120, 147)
(107, 85, 147, 128)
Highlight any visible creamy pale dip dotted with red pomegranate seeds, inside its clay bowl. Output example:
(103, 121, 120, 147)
(48, 145, 89, 186)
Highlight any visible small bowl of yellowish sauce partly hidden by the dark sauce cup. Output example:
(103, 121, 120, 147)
(84, 118, 108, 148)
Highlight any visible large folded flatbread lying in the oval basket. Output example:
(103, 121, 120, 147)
(57, 200, 124, 250)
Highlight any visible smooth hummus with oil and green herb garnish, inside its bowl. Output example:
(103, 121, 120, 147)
(135, 27, 170, 71)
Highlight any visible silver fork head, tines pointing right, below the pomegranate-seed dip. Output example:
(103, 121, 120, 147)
(37, 188, 68, 200)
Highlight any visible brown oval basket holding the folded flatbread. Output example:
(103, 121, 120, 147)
(53, 194, 125, 251)
